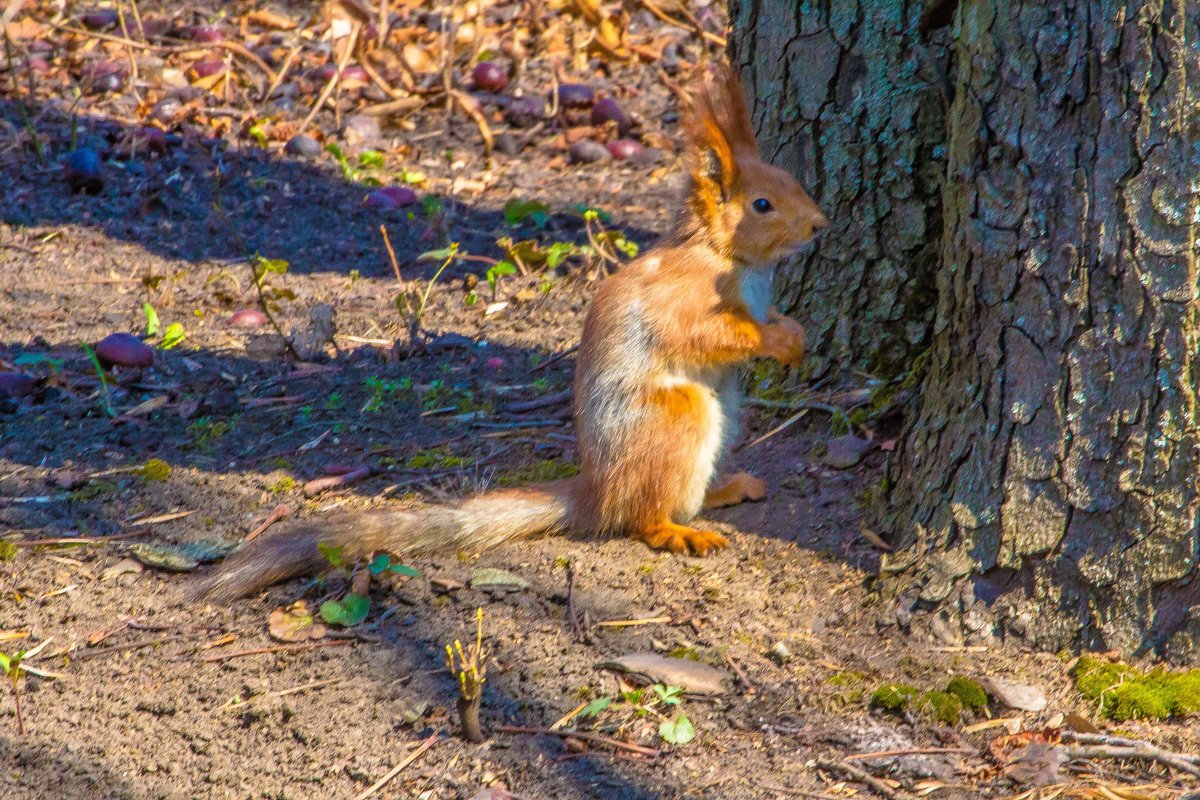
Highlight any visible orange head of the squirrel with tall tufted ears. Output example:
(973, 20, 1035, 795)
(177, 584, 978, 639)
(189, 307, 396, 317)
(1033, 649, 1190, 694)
(683, 62, 829, 266)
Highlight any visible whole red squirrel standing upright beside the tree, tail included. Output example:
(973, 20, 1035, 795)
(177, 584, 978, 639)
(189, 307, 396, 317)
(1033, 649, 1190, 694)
(198, 64, 828, 600)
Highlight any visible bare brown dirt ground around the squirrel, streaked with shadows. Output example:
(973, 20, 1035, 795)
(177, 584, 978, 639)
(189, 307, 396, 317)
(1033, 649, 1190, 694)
(0, 1, 1200, 800)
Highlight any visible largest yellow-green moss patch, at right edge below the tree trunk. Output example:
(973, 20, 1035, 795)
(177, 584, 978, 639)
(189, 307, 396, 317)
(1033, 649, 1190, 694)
(1070, 655, 1200, 721)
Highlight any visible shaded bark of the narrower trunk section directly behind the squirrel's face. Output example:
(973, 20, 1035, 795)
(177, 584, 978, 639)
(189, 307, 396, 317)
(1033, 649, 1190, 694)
(730, 0, 948, 377)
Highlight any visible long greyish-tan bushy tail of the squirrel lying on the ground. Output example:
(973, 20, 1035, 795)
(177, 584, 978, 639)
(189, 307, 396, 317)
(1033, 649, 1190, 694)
(192, 480, 575, 602)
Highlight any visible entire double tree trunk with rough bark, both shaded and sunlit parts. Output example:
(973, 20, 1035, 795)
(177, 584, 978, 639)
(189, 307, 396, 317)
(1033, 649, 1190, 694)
(731, 0, 1200, 662)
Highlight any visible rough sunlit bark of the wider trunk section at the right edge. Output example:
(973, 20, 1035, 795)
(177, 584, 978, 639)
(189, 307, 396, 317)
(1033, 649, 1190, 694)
(882, 0, 1200, 661)
